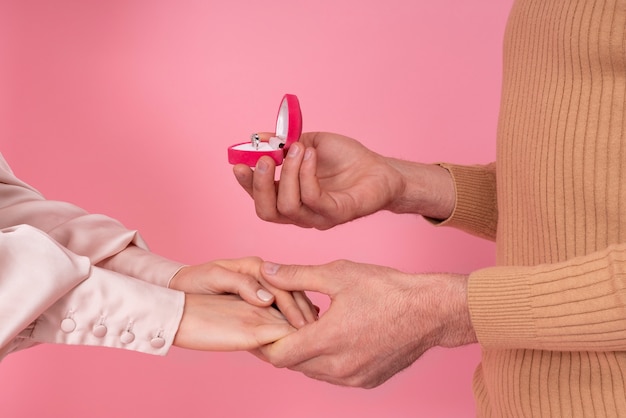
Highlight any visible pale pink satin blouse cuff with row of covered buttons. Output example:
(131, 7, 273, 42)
(31, 267, 185, 355)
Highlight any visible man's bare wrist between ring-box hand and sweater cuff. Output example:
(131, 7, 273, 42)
(386, 158, 456, 220)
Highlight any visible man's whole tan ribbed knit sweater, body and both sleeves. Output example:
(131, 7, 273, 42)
(438, 0, 626, 418)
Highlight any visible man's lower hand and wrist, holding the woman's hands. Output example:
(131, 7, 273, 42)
(257, 261, 476, 388)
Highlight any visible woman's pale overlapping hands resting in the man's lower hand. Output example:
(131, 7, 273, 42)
(169, 257, 317, 351)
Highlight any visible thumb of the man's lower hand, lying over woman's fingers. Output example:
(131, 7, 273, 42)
(261, 261, 334, 295)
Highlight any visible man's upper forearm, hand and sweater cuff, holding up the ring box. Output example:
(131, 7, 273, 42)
(234, 132, 497, 239)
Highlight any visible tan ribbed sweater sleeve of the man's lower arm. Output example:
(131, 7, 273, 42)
(469, 244, 626, 351)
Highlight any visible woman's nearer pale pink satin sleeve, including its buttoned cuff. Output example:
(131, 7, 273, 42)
(0, 225, 184, 358)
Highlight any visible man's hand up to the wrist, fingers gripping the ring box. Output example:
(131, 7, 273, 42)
(233, 133, 404, 230)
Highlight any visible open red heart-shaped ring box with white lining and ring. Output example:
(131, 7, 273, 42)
(228, 94, 302, 167)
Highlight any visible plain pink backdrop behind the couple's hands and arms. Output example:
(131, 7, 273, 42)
(0, 0, 512, 418)
